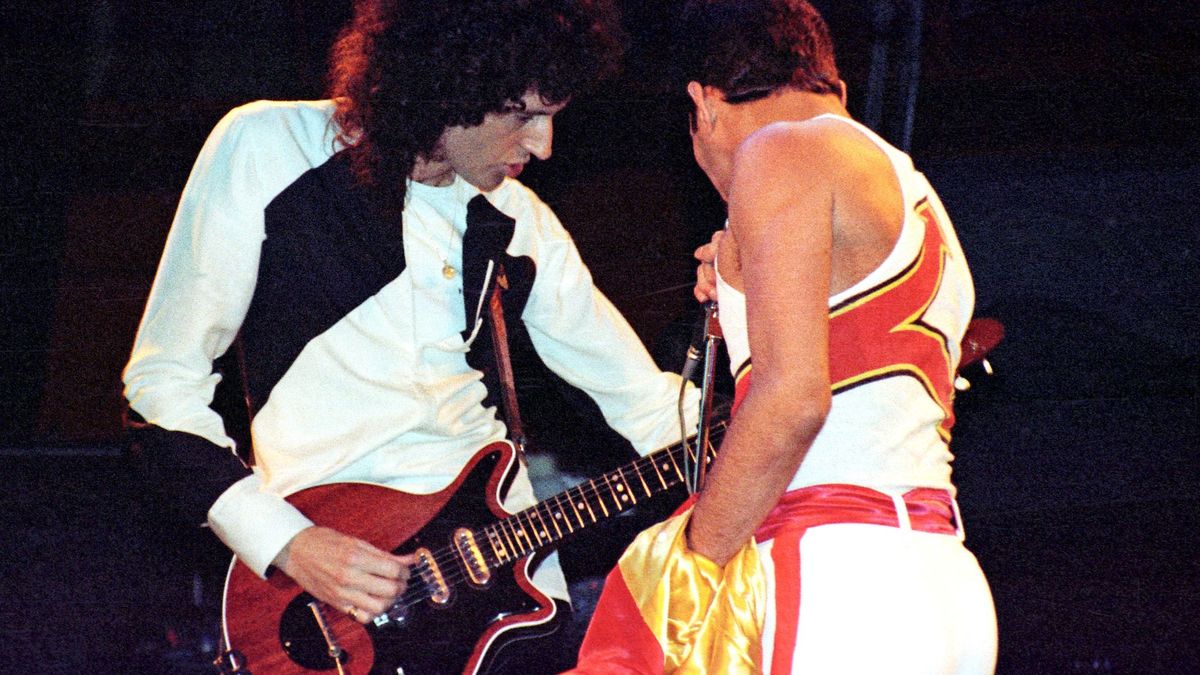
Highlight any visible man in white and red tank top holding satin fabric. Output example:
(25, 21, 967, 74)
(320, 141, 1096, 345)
(578, 0, 996, 675)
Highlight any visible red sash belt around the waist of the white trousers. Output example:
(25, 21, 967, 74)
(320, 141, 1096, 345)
(755, 484, 959, 542)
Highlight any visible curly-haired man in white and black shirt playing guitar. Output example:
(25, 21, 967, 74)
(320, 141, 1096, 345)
(124, 0, 696, 669)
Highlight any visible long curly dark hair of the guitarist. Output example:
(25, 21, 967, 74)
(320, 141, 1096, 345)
(329, 0, 618, 205)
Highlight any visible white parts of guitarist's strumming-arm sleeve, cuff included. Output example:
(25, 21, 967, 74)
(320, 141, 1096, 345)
(124, 108, 311, 575)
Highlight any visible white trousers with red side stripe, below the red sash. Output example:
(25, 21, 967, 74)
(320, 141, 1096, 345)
(758, 524, 997, 675)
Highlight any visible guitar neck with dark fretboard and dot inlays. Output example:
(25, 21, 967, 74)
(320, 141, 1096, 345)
(480, 422, 726, 567)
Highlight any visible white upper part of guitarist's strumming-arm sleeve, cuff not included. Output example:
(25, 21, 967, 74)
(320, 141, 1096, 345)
(124, 106, 263, 448)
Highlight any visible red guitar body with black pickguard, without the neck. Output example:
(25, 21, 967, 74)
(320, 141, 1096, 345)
(224, 442, 559, 675)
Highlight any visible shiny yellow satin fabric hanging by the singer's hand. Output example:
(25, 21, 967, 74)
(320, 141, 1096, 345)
(618, 509, 767, 675)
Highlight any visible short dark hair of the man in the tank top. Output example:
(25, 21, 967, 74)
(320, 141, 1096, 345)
(676, 0, 841, 103)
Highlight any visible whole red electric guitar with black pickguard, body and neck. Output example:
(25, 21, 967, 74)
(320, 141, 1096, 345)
(223, 423, 725, 675)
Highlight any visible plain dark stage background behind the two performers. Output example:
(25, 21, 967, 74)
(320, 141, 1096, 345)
(0, 0, 1200, 673)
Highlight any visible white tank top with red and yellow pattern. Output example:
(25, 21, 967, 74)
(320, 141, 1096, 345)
(716, 115, 974, 494)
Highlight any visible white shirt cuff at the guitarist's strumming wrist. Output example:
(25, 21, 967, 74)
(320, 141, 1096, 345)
(209, 472, 313, 579)
